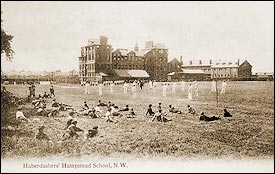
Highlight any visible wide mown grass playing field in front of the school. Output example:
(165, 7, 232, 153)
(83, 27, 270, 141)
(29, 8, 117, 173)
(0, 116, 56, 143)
(1, 81, 274, 159)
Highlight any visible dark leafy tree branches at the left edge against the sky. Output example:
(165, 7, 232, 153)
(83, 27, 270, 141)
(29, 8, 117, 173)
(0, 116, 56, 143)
(1, 11, 14, 60)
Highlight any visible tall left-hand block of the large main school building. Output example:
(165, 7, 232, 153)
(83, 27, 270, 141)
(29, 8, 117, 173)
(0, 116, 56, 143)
(79, 36, 113, 81)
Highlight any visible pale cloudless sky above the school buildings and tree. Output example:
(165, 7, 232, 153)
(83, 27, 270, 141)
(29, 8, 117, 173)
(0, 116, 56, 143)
(1, 1, 274, 73)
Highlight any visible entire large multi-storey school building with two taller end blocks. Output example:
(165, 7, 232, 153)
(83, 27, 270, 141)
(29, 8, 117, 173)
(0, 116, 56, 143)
(79, 36, 168, 81)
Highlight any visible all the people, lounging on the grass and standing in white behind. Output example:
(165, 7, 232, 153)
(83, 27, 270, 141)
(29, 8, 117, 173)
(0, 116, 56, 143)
(5, 81, 232, 141)
